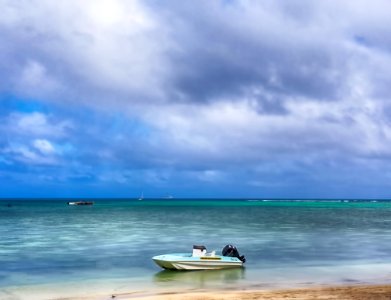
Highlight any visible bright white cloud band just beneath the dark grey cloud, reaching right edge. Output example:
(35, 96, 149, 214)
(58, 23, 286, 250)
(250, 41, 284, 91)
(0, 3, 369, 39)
(146, 89, 391, 169)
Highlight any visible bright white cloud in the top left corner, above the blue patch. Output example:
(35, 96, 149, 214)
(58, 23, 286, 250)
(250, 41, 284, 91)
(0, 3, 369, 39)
(0, 0, 170, 106)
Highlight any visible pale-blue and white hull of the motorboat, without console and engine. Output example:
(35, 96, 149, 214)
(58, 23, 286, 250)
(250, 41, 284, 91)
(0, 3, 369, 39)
(152, 253, 243, 270)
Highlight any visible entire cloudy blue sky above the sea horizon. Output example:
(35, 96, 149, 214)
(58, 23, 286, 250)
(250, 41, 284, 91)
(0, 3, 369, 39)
(0, 0, 391, 198)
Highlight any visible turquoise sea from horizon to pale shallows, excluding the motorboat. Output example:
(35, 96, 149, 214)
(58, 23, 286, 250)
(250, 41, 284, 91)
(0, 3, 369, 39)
(0, 200, 391, 288)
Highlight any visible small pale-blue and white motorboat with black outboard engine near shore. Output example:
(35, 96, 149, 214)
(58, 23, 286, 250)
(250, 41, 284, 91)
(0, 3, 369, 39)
(152, 245, 246, 270)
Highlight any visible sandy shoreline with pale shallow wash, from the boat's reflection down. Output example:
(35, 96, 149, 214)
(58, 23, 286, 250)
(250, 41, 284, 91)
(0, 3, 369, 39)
(0, 263, 391, 300)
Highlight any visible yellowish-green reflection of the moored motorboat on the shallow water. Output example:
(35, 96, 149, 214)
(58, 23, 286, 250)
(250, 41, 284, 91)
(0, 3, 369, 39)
(154, 267, 245, 288)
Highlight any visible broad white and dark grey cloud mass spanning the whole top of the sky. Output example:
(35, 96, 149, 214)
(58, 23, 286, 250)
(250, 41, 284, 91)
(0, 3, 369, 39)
(0, 0, 389, 112)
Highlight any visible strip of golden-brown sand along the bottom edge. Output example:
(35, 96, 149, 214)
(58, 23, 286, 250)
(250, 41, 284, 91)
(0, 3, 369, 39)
(0, 283, 391, 300)
